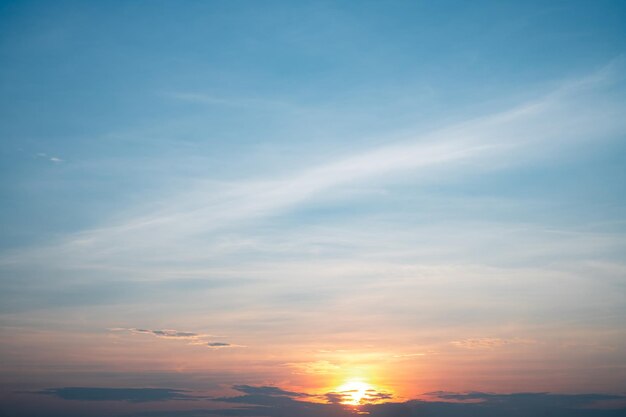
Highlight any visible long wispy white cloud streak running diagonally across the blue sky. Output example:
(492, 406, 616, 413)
(3, 63, 626, 268)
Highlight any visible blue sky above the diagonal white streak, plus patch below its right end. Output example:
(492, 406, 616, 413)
(0, 1, 626, 247)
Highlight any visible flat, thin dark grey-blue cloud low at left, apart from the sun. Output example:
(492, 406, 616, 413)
(38, 387, 197, 402)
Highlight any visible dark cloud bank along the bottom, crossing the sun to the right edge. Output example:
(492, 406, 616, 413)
(123, 385, 626, 417)
